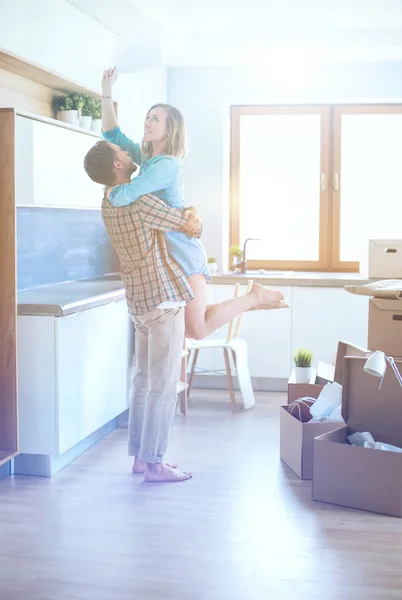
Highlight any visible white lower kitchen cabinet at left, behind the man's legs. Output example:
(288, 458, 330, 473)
(16, 300, 130, 474)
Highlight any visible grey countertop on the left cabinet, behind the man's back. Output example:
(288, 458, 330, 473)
(17, 277, 125, 317)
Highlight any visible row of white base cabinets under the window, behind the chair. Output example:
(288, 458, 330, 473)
(193, 284, 368, 389)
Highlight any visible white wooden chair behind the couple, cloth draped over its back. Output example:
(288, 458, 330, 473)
(186, 281, 255, 412)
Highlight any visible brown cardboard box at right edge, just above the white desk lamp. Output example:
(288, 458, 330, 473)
(368, 298, 402, 356)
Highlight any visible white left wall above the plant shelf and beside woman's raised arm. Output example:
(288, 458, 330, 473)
(0, 0, 166, 137)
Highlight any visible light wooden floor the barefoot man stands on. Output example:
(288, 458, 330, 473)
(0, 390, 402, 600)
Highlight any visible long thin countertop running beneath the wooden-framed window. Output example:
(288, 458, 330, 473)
(212, 271, 373, 287)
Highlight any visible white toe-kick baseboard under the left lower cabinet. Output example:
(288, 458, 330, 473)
(14, 413, 124, 477)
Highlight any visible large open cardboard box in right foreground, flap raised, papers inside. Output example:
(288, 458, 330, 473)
(313, 357, 402, 517)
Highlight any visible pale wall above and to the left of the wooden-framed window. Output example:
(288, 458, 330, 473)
(168, 64, 402, 264)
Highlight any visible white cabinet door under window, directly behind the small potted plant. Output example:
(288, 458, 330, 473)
(291, 287, 368, 364)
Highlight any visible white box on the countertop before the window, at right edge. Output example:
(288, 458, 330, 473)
(360, 240, 402, 279)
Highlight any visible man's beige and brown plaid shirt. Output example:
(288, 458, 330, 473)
(102, 194, 199, 315)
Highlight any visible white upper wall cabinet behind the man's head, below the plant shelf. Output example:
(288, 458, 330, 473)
(15, 115, 102, 208)
